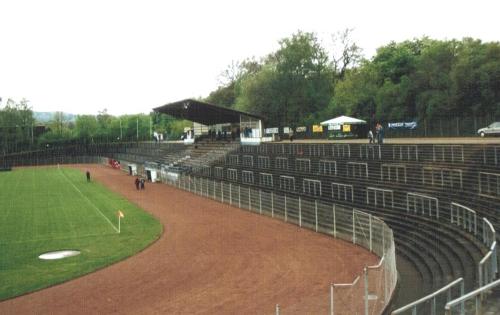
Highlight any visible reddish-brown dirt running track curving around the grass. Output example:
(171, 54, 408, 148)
(0, 166, 377, 315)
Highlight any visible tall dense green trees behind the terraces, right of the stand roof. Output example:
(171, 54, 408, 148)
(206, 30, 500, 126)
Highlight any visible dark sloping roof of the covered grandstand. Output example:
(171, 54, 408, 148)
(153, 99, 264, 125)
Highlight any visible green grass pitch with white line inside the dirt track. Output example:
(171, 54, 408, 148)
(0, 167, 162, 300)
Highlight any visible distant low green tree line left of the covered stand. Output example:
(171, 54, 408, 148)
(0, 99, 190, 154)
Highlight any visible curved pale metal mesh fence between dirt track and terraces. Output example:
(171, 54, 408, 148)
(160, 172, 397, 315)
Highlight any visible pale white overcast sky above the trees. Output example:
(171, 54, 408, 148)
(0, 0, 500, 115)
